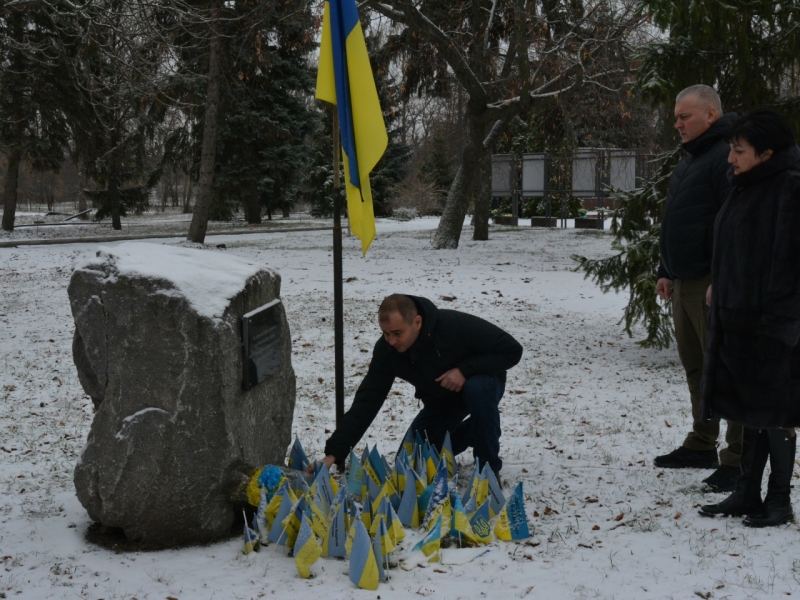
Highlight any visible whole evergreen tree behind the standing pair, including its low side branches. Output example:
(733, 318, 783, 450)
(573, 0, 800, 348)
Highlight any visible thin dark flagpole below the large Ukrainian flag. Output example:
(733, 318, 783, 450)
(332, 106, 345, 466)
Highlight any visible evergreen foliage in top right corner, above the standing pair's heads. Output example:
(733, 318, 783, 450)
(639, 0, 800, 123)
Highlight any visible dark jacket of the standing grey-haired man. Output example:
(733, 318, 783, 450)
(658, 113, 736, 280)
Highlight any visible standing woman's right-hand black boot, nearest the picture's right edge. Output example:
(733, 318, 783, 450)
(743, 429, 797, 527)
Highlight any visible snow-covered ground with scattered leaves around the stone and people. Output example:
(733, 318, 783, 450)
(0, 219, 800, 600)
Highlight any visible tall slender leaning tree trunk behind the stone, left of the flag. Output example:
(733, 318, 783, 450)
(186, 1, 222, 244)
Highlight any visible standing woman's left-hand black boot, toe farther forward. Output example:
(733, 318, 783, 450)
(699, 427, 769, 517)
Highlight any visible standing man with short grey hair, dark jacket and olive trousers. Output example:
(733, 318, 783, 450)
(653, 85, 742, 492)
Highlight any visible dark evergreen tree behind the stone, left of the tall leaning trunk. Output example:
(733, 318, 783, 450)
(62, 0, 167, 230)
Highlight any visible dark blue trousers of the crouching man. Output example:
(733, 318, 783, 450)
(409, 375, 505, 473)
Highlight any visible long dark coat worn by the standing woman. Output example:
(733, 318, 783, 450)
(703, 146, 800, 428)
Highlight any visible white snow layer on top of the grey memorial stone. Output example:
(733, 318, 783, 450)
(75, 242, 265, 319)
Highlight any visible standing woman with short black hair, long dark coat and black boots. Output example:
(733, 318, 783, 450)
(700, 109, 800, 527)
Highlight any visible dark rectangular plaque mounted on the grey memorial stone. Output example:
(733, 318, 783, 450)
(242, 298, 282, 390)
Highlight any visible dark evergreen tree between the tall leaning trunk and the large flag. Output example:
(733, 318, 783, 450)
(216, 1, 317, 223)
